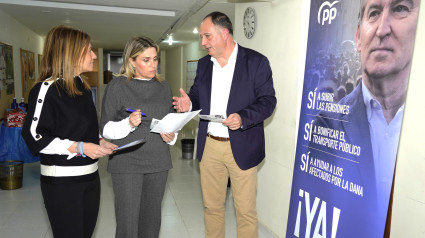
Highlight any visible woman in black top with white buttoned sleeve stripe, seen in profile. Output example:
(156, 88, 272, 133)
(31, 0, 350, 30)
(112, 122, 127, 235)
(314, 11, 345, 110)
(22, 26, 117, 238)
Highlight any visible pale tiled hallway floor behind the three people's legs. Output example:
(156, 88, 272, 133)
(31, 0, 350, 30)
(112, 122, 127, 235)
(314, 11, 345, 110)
(0, 146, 275, 238)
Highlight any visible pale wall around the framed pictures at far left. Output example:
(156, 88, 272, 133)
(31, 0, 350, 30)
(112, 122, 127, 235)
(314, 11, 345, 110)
(0, 10, 44, 113)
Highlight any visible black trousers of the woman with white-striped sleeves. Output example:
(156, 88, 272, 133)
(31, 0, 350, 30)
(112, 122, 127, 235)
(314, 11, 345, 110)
(41, 177, 100, 238)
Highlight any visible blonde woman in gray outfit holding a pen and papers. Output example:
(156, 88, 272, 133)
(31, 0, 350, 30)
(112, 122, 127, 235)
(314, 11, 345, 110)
(100, 36, 176, 238)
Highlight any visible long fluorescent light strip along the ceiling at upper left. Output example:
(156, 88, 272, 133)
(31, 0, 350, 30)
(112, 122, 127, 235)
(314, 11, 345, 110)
(0, 0, 176, 17)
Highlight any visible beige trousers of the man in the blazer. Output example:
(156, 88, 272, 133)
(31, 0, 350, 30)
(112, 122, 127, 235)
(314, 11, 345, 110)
(200, 137, 258, 238)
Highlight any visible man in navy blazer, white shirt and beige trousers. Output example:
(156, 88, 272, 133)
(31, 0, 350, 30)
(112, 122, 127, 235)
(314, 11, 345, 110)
(173, 12, 276, 238)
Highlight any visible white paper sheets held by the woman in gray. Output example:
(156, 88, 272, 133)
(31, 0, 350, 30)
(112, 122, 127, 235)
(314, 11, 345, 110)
(150, 110, 201, 133)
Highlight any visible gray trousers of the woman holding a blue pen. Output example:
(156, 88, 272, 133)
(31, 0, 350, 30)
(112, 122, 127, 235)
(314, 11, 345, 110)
(111, 170, 168, 238)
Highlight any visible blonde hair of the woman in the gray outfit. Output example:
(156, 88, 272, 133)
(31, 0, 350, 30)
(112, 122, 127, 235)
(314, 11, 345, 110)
(115, 36, 161, 82)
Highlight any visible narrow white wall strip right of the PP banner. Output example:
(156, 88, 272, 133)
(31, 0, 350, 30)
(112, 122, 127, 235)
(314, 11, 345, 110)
(391, 2, 425, 237)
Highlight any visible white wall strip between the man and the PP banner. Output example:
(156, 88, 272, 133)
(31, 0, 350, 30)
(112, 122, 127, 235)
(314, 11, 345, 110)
(233, 0, 302, 237)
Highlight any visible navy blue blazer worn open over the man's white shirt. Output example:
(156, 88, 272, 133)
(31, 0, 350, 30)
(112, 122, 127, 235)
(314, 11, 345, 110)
(188, 45, 276, 170)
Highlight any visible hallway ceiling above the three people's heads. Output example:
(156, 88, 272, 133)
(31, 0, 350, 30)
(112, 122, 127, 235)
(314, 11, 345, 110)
(0, 0, 238, 50)
